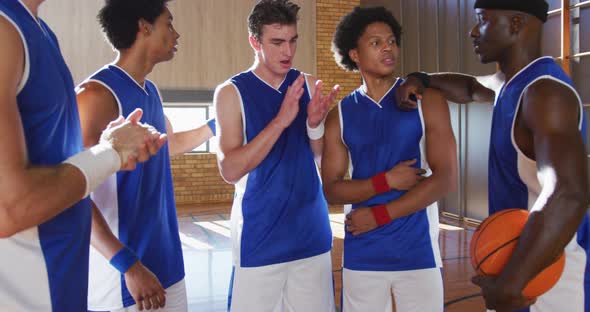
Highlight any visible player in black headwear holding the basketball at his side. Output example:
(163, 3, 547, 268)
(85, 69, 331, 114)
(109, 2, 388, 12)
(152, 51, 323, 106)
(400, 0, 590, 312)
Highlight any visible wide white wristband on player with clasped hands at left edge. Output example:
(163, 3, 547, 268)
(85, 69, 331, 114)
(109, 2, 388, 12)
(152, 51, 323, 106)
(64, 143, 121, 197)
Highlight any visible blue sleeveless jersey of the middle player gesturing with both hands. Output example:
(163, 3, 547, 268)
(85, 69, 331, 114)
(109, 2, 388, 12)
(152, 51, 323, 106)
(231, 69, 332, 267)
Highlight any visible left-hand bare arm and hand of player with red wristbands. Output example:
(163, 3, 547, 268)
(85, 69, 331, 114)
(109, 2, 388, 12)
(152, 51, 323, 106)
(321, 106, 426, 205)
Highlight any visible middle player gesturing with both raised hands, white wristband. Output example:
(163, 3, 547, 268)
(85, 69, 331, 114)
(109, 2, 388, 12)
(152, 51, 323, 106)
(214, 0, 338, 312)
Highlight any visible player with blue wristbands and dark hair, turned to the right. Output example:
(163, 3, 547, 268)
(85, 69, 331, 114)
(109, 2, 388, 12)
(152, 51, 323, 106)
(78, 0, 213, 311)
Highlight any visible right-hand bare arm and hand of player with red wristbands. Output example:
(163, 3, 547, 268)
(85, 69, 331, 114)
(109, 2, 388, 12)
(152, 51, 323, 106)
(346, 90, 457, 235)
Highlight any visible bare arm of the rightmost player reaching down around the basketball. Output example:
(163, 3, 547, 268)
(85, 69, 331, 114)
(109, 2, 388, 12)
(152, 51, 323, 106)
(473, 79, 590, 312)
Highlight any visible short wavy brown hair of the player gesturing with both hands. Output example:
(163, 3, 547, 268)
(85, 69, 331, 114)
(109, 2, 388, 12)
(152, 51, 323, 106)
(248, 0, 300, 41)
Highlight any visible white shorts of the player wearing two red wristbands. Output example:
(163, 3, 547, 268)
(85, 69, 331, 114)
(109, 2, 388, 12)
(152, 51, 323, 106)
(342, 268, 444, 312)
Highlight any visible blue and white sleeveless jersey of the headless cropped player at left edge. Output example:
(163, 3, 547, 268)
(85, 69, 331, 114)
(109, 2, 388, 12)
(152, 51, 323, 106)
(0, 1, 91, 312)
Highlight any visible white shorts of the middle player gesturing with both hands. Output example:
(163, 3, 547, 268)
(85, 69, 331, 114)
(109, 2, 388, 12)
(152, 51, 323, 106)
(229, 252, 335, 312)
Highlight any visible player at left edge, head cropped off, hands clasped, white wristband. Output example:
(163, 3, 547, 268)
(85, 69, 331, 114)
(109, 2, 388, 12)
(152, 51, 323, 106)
(0, 0, 165, 312)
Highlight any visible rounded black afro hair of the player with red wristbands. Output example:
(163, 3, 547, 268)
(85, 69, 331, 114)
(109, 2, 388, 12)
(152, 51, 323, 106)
(332, 7, 402, 71)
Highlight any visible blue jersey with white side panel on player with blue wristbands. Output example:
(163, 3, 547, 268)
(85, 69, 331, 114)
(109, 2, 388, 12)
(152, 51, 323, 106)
(82, 65, 184, 310)
